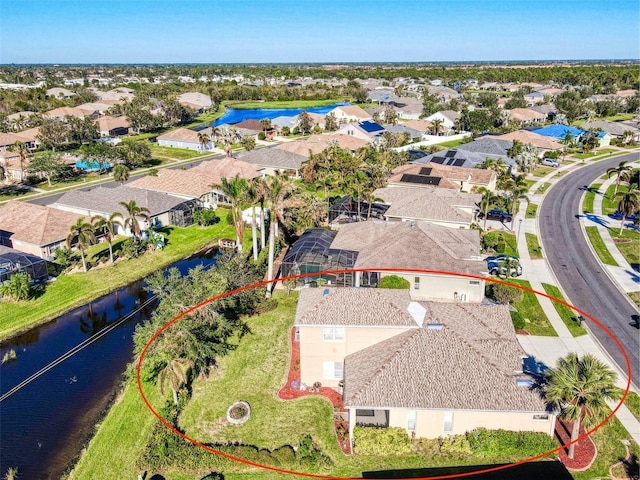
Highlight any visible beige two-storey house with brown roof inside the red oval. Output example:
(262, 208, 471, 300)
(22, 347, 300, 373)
(294, 288, 554, 438)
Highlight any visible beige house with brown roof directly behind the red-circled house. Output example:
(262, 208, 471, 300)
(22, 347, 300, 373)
(331, 220, 487, 302)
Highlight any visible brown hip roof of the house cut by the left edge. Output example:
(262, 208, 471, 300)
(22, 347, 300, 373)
(0, 200, 82, 246)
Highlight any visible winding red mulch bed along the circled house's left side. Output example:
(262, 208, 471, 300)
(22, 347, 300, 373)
(278, 327, 351, 454)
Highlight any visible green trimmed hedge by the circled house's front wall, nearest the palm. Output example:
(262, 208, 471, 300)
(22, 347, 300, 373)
(467, 428, 557, 458)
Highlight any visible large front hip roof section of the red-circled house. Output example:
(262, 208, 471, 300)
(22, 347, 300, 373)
(344, 303, 545, 412)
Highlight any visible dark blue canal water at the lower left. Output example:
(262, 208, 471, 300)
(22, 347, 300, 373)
(0, 252, 215, 479)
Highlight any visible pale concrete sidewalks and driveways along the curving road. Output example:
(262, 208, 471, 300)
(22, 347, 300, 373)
(504, 156, 640, 444)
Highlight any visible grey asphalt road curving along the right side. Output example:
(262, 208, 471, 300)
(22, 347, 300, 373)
(538, 153, 640, 388)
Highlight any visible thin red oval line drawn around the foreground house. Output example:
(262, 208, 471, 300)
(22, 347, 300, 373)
(136, 268, 631, 480)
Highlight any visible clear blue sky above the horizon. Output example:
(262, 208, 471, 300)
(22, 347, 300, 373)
(0, 0, 640, 64)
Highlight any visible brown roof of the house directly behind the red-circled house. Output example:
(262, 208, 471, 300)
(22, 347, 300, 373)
(331, 221, 487, 276)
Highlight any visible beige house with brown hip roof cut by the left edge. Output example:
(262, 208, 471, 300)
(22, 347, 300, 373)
(0, 200, 84, 260)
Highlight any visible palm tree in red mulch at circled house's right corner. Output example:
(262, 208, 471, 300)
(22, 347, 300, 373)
(545, 353, 621, 458)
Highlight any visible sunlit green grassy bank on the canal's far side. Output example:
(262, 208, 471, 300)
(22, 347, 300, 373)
(0, 221, 238, 339)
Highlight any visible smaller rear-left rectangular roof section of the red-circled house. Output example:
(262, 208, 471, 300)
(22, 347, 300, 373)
(295, 288, 419, 328)
